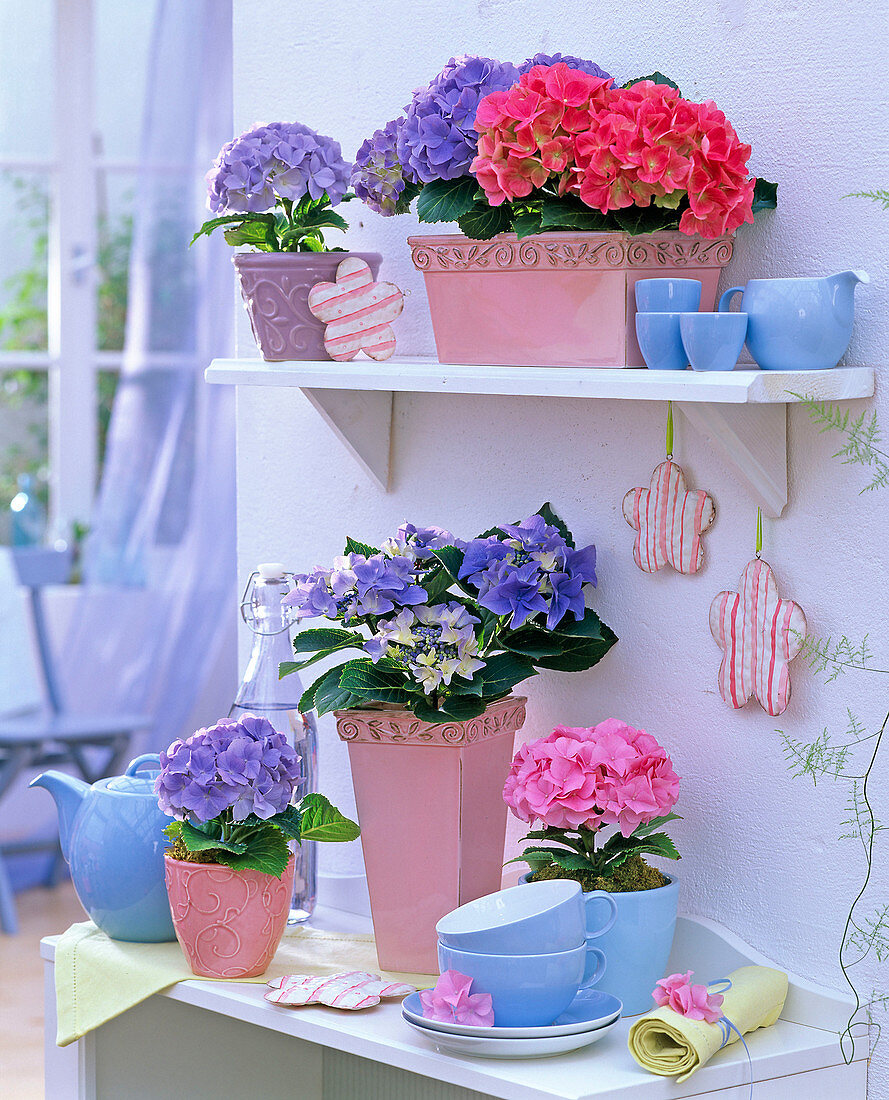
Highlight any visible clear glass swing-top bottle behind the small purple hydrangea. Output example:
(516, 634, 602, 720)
(229, 562, 318, 924)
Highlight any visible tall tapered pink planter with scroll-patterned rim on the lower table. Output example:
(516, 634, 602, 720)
(337, 697, 525, 974)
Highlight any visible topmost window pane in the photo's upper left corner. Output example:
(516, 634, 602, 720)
(0, 0, 55, 161)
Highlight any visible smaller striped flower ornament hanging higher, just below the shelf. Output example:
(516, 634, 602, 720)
(623, 459, 716, 573)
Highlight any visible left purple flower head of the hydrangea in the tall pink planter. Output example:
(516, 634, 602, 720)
(283, 553, 426, 623)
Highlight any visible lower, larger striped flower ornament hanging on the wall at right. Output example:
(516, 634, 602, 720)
(710, 557, 806, 717)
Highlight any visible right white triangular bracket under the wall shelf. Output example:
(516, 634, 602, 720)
(677, 402, 787, 519)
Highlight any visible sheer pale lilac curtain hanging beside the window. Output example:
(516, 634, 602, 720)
(59, 0, 238, 751)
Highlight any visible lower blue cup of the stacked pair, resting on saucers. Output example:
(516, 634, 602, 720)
(438, 941, 605, 1027)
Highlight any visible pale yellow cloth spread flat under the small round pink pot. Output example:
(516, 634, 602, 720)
(55, 921, 433, 1046)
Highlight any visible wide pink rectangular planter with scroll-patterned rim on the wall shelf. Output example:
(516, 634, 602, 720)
(407, 230, 732, 366)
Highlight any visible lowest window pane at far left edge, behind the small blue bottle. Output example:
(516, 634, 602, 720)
(0, 371, 47, 545)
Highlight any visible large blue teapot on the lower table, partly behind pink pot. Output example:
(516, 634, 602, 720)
(30, 754, 176, 943)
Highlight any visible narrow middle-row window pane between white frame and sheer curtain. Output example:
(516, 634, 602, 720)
(96, 172, 135, 351)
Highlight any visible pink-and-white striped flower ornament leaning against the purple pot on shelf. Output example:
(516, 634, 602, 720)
(308, 256, 404, 363)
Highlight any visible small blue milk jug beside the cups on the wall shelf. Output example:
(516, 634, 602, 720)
(718, 272, 870, 371)
